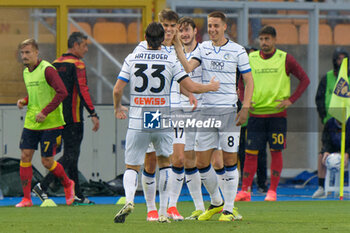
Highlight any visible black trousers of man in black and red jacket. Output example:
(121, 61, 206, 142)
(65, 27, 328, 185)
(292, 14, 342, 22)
(41, 123, 84, 198)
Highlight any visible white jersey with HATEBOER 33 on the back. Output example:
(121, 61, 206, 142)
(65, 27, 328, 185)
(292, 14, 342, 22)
(118, 49, 188, 130)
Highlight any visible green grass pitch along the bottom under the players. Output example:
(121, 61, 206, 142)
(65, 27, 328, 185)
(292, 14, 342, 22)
(0, 201, 350, 233)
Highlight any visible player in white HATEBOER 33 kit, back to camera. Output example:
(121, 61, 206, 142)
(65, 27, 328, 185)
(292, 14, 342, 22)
(113, 23, 220, 223)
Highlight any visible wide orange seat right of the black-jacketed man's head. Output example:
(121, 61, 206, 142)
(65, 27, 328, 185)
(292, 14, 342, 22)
(93, 22, 127, 44)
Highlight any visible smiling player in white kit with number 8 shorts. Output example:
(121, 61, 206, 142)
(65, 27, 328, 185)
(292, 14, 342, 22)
(174, 11, 254, 221)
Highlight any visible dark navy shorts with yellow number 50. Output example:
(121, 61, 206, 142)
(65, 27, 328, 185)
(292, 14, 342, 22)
(246, 117, 287, 150)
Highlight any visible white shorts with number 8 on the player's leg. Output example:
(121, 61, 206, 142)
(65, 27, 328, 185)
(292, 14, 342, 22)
(195, 113, 240, 153)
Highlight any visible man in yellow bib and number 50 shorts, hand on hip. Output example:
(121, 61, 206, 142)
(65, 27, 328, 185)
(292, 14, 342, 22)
(235, 26, 310, 201)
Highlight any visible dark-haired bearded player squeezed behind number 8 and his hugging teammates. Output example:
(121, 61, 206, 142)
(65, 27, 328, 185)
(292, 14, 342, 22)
(168, 17, 205, 220)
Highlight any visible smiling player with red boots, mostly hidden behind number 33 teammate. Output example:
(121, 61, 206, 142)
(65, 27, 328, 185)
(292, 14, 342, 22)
(133, 9, 197, 221)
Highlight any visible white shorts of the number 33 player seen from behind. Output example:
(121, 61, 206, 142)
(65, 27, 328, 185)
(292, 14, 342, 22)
(125, 130, 173, 165)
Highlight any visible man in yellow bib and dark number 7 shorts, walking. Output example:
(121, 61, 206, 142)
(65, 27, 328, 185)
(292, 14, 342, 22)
(16, 39, 75, 207)
